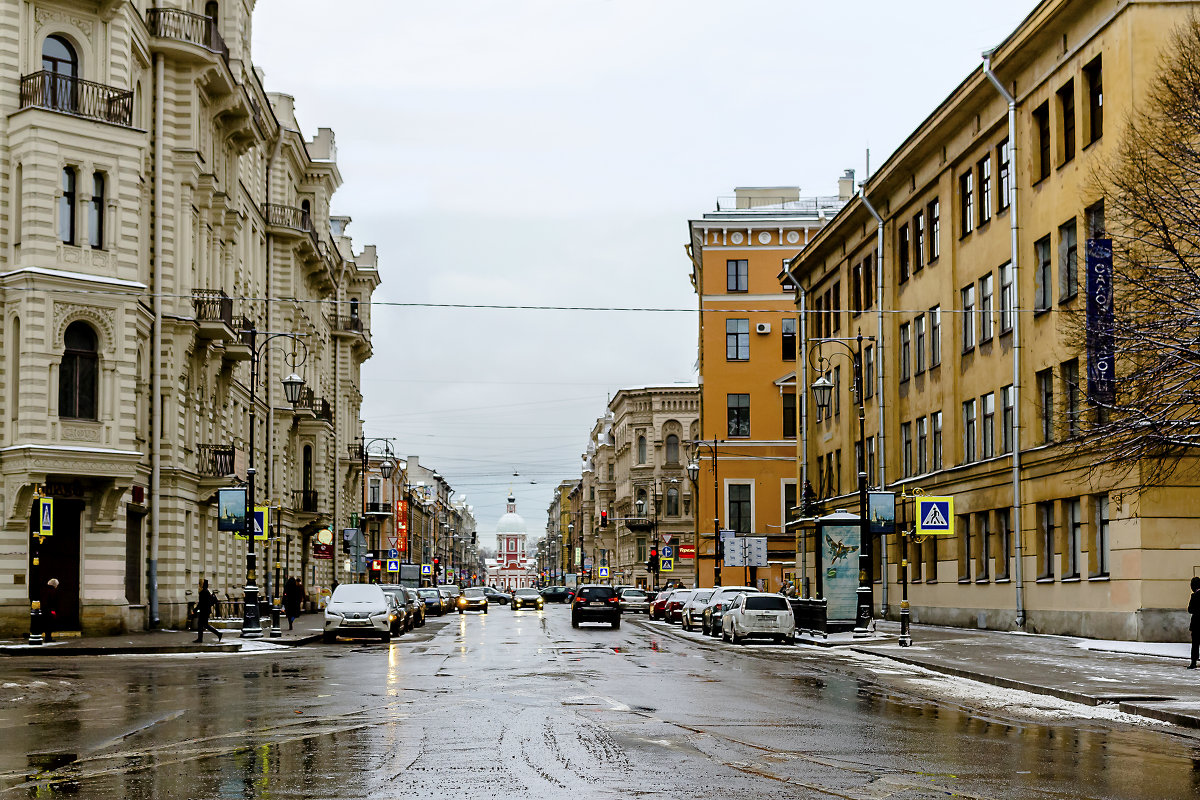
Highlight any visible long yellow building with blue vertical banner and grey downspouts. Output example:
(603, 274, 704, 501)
(787, 0, 1200, 639)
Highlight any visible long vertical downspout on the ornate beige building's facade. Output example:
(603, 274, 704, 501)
(146, 53, 164, 627)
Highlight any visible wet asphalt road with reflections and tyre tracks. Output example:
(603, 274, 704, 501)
(0, 606, 1200, 800)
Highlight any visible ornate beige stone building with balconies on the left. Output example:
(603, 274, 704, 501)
(0, 0, 379, 634)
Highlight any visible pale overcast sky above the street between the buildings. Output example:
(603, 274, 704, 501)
(253, 0, 1034, 546)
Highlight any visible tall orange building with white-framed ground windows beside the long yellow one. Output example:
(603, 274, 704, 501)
(688, 184, 854, 589)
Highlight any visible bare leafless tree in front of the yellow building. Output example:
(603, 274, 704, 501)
(1064, 16, 1200, 482)
